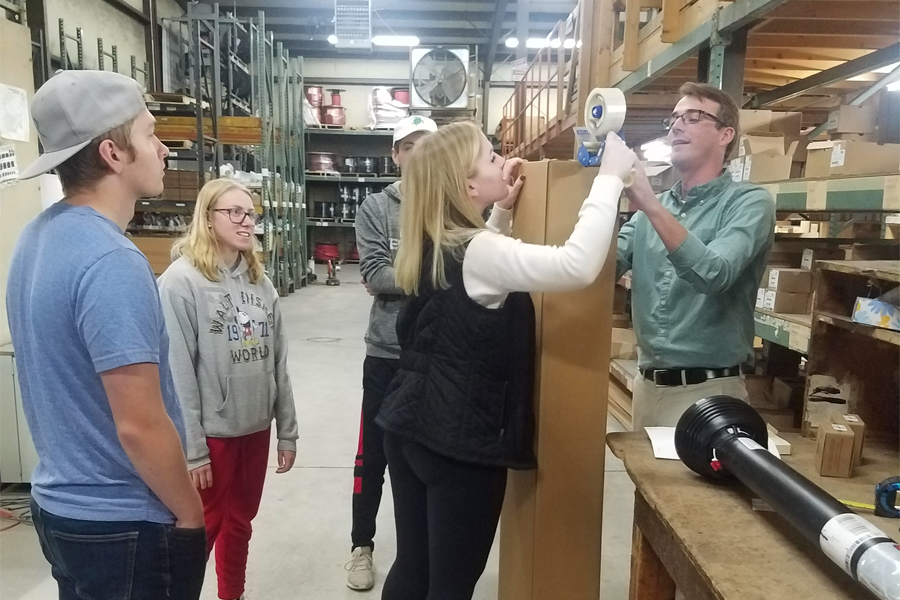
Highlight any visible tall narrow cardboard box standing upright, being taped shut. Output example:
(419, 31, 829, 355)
(499, 161, 615, 600)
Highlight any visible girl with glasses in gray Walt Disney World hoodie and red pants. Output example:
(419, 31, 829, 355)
(159, 179, 298, 600)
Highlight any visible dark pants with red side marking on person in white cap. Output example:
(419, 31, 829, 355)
(350, 356, 400, 549)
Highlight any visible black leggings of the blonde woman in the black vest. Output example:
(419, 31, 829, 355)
(381, 433, 506, 600)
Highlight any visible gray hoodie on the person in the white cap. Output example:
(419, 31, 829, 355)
(356, 182, 403, 358)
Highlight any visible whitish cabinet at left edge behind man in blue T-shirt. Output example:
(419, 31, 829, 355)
(0, 346, 38, 483)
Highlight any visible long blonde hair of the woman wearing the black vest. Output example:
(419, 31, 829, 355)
(394, 122, 485, 295)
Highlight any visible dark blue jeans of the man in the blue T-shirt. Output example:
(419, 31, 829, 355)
(31, 499, 206, 600)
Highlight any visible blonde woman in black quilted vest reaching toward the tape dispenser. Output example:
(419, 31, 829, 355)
(376, 123, 635, 600)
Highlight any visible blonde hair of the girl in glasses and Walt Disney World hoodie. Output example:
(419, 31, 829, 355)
(172, 179, 264, 283)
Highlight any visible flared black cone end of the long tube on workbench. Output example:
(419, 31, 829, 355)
(675, 396, 769, 479)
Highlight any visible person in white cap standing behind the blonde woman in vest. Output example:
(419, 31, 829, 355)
(347, 115, 437, 590)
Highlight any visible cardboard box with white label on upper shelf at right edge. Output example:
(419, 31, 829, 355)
(806, 140, 900, 178)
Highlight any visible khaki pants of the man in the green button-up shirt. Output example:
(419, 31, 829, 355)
(631, 375, 748, 431)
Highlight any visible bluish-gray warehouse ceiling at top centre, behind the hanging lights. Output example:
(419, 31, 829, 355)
(197, 0, 577, 62)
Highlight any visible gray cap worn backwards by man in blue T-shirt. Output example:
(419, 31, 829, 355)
(19, 71, 147, 179)
